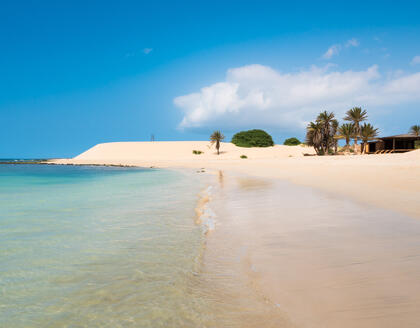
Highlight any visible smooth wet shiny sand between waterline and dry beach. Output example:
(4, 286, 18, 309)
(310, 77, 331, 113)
(205, 175, 420, 328)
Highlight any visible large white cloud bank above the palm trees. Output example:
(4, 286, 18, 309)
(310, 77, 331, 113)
(174, 65, 420, 130)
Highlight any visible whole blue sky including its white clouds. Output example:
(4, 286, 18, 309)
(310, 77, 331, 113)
(0, 0, 420, 158)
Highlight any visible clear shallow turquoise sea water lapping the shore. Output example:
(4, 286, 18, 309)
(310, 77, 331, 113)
(0, 165, 217, 327)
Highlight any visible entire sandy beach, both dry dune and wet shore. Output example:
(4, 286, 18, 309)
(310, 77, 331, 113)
(53, 142, 420, 328)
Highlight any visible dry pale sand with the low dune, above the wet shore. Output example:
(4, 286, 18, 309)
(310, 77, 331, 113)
(52, 141, 420, 218)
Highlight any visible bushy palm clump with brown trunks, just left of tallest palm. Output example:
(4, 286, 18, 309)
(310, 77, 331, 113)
(306, 111, 338, 155)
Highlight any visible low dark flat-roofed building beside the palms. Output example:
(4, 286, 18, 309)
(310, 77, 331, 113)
(366, 134, 420, 154)
